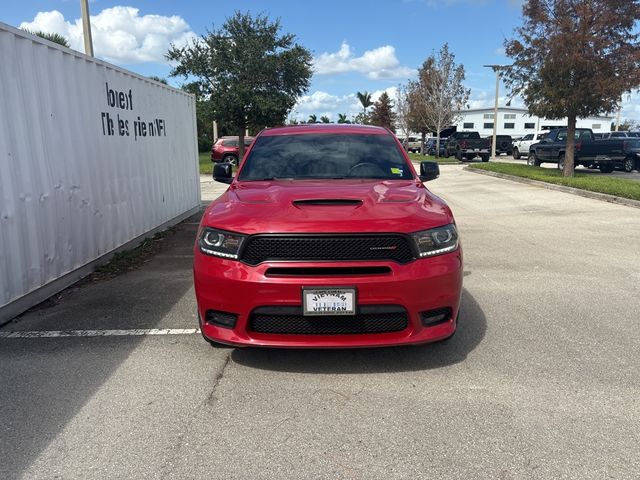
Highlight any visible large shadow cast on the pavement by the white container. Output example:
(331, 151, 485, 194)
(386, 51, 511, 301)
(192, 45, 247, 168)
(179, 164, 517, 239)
(0, 213, 201, 479)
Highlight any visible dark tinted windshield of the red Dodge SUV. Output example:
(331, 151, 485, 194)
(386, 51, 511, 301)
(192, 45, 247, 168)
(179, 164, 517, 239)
(238, 134, 413, 181)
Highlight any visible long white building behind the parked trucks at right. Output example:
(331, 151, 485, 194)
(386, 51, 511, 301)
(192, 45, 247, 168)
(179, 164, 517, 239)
(455, 107, 613, 137)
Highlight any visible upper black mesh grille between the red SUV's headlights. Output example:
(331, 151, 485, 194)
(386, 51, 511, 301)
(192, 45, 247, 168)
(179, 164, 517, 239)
(240, 235, 414, 265)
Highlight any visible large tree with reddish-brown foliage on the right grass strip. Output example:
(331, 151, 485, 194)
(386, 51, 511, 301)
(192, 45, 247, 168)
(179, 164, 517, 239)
(504, 0, 640, 177)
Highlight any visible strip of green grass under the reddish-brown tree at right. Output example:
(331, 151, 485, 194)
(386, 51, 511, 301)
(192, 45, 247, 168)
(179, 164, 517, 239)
(469, 162, 640, 200)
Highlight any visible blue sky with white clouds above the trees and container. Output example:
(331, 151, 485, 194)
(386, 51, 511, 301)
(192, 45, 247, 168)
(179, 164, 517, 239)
(0, 0, 640, 121)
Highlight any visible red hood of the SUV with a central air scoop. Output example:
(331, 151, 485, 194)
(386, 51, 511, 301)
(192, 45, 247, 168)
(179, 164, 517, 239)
(202, 179, 453, 235)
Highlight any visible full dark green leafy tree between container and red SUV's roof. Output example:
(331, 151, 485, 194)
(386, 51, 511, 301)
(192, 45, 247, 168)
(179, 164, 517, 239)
(166, 12, 312, 157)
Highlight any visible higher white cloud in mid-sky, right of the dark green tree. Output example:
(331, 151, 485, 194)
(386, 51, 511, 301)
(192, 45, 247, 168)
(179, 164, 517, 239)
(314, 42, 415, 80)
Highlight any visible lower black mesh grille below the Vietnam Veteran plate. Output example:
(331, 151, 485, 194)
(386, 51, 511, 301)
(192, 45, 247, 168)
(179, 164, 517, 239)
(249, 308, 409, 335)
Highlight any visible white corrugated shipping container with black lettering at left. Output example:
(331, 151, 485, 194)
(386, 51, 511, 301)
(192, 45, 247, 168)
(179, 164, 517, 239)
(0, 23, 200, 322)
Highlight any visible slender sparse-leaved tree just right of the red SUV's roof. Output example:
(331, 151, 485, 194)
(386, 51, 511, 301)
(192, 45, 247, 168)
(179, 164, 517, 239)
(409, 43, 471, 156)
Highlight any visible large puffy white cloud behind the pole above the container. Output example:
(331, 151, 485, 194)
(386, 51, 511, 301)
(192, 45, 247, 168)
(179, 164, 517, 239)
(20, 7, 196, 64)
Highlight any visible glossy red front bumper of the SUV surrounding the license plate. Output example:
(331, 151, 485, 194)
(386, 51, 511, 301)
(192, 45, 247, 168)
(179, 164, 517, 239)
(194, 247, 462, 348)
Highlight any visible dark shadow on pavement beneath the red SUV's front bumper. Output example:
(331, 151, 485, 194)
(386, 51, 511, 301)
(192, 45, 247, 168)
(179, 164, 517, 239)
(231, 289, 487, 374)
